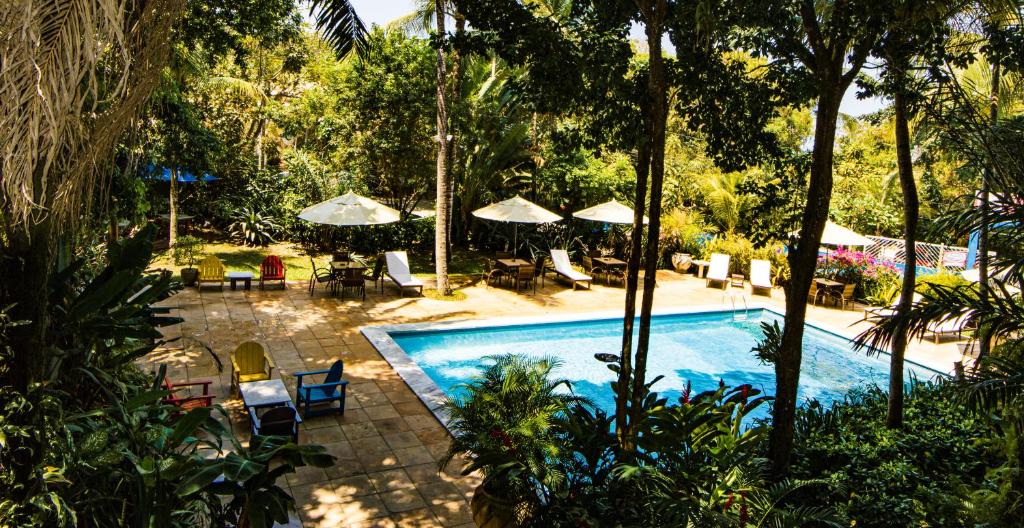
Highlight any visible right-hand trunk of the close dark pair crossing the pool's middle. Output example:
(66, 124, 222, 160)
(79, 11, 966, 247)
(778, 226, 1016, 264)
(630, 0, 669, 439)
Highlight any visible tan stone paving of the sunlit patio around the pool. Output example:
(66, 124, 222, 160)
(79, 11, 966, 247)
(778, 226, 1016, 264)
(145, 271, 961, 528)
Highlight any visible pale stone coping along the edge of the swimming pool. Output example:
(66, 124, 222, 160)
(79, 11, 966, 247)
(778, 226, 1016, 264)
(359, 303, 949, 430)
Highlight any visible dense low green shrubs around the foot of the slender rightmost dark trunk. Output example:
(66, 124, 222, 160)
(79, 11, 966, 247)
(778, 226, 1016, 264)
(793, 383, 998, 527)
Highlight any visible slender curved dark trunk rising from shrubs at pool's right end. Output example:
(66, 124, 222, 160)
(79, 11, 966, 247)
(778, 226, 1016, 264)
(886, 90, 920, 429)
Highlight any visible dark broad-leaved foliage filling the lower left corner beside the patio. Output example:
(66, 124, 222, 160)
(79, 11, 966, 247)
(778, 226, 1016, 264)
(0, 225, 327, 528)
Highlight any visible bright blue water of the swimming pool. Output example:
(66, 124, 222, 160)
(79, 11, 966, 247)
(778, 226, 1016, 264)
(390, 310, 936, 416)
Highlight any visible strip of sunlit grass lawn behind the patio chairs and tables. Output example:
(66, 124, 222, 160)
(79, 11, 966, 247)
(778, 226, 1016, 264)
(152, 240, 487, 281)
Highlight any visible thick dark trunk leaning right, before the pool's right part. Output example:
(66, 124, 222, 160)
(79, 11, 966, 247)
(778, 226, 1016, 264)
(768, 85, 846, 476)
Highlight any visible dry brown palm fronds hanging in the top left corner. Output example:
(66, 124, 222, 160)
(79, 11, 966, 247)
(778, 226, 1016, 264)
(0, 0, 183, 237)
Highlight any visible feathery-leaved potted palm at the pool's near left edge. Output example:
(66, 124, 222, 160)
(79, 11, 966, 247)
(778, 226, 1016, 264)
(438, 354, 589, 528)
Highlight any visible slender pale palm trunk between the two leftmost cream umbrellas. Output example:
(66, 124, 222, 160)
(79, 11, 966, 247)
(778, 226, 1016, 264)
(434, 0, 452, 295)
